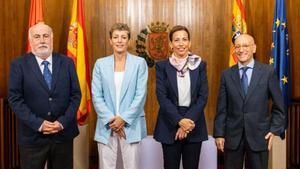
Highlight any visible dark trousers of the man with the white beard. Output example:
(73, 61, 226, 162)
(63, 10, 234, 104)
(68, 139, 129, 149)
(20, 141, 73, 169)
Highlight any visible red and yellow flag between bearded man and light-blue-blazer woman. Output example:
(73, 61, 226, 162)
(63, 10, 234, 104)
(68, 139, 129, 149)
(67, 0, 91, 125)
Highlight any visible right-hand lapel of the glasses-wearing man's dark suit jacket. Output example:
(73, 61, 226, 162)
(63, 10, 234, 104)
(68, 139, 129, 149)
(245, 62, 263, 102)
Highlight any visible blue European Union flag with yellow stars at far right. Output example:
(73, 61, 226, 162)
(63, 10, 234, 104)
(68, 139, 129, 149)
(270, 0, 291, 137)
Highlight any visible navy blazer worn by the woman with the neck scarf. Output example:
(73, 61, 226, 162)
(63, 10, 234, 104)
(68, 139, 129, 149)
(154, 60, 208, 144)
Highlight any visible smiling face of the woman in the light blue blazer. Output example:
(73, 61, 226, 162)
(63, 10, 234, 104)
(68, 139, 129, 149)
(109, 30, 129, 54)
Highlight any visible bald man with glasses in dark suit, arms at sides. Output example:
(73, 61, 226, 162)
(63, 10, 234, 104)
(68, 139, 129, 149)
(214, 34, 285, 169)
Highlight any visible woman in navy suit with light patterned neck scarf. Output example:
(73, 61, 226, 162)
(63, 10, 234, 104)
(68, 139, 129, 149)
(154, 25, 208, 169)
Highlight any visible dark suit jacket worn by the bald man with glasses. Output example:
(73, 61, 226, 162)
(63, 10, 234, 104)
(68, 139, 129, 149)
(214, 61, 285, 151)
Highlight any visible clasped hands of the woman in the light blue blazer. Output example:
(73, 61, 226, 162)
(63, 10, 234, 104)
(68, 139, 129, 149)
(109, 116, 126, 139)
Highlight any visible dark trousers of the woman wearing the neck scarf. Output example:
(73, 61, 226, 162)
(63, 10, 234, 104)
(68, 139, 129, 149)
(162, 139, 202, 169)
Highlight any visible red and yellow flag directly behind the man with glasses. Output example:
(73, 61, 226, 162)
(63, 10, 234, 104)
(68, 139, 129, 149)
(229, 0, 247, 66)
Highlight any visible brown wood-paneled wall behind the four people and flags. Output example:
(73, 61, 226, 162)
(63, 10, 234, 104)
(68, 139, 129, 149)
(0, 0, 300, 155)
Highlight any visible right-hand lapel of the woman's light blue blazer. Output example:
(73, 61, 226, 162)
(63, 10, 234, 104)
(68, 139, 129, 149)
(120, 53, 135, 103)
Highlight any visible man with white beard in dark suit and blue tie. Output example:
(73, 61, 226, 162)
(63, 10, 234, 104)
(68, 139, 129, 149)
(8, 23, 81, 169)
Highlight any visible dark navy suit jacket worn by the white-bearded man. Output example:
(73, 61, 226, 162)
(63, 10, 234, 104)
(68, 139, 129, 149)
(8, 53, 81, 146)
